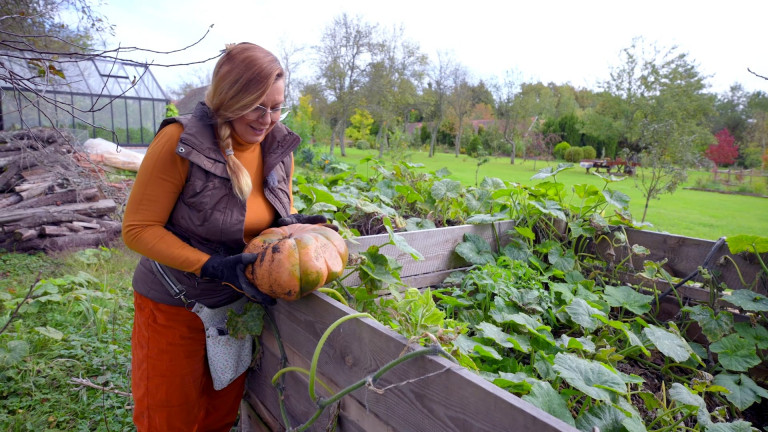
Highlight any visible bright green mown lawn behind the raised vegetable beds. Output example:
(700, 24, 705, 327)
(328, 148, 768, 240)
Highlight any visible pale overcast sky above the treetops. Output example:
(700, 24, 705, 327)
(99, 0, 768, 98)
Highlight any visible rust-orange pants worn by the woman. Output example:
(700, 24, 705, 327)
(131, 293, 246, 432)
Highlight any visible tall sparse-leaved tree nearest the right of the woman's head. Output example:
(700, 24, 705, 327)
(316, 13, 377, 156)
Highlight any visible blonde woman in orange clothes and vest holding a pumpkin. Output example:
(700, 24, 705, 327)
(123, 43, 325, 431)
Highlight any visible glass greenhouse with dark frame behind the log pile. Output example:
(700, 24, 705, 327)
(0, 51, 169, 146)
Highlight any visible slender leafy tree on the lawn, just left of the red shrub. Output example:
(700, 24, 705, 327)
(606, 39, 714, 222)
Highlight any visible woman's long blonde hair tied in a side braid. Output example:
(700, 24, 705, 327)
(205, 42, 284, 201)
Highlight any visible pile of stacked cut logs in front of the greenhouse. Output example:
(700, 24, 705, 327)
(0, 128, 127, 252)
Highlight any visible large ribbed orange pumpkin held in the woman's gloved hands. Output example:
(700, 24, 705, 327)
(243, 224, 349, 300)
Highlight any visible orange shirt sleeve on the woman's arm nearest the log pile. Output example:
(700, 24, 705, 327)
(123, 123, 210, 274)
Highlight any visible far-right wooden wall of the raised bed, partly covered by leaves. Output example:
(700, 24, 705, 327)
(597, 229, 768, 294)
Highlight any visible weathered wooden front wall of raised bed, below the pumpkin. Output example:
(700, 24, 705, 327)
(248, 294, 575, 432)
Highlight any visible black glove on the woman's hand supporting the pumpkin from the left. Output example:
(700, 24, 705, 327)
(200, 254, 275, 306)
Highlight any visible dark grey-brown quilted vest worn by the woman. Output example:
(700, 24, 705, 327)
(133, 102, 301, 308)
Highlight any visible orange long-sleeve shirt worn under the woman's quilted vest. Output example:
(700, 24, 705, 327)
(123, 123, 293, 274)
